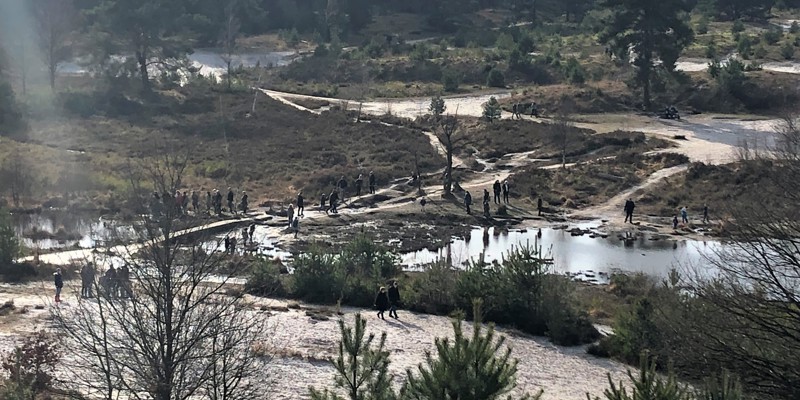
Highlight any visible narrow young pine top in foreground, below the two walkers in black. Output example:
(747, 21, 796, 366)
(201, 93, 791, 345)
(310, 314, 397, 400)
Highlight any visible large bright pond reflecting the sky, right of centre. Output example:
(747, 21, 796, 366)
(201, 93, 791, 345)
(402, 228, 720, 280)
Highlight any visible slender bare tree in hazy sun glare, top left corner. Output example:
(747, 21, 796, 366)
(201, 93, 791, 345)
(30, 0, 78, 91)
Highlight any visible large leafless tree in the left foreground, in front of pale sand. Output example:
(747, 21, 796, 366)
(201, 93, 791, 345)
(52, 151, 264, 400)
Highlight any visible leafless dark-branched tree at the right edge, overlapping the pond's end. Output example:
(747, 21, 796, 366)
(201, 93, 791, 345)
(681, 114, 800, 398)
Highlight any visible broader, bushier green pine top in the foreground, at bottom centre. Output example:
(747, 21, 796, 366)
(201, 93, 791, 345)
(401, 302, 541, 400)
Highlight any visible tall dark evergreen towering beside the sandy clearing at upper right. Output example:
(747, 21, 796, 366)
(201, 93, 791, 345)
(600, 0, 694, 108)
